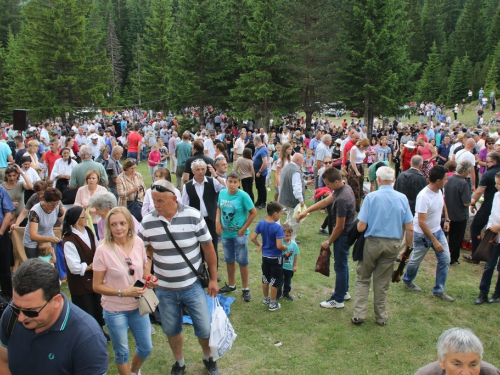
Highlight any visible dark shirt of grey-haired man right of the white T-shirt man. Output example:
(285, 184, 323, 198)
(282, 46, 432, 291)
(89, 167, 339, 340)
(444, 175, 471, 221)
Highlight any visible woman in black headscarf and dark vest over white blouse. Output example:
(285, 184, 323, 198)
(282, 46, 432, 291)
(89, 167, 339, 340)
(62, 206, 110, 341)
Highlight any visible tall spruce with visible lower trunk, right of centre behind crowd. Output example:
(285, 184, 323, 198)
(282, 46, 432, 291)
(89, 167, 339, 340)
(335, 0, 416, 137)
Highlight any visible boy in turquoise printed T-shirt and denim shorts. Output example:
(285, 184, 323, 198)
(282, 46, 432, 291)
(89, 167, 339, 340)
(215, 171, 257, 302)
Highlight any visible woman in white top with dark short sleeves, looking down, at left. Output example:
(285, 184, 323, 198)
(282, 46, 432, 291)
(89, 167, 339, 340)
(23, 188, 65, 258)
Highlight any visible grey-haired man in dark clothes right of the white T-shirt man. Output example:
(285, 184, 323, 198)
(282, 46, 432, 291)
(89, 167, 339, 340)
(444, 160, 474, 265)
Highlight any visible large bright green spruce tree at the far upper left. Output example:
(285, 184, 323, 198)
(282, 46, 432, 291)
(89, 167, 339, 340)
(9, 0, 110, 119)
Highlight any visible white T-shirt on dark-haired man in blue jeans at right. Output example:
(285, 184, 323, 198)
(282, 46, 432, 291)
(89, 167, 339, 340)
(413, 186, 444, 234)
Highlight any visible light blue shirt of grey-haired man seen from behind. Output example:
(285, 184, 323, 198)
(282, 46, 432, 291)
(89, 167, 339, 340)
(358, 185, 413, 239)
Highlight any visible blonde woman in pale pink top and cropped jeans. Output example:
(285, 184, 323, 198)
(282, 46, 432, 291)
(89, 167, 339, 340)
(92, 207, 158, 375)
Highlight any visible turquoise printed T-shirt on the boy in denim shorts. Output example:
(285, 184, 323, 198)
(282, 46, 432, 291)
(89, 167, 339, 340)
(217, 189, 254, 238)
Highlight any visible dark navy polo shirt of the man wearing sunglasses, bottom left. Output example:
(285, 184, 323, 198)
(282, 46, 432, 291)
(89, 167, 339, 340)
(0, 295, 109, 375)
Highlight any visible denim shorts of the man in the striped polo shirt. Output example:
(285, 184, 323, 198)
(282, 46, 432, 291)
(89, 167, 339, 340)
(155, 281, 210, 339)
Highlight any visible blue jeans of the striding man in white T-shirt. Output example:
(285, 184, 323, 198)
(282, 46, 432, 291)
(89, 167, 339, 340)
(403, 229, 450, 294)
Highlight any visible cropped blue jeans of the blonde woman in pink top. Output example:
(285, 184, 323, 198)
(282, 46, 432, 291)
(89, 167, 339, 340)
(103, 309, 153, 365)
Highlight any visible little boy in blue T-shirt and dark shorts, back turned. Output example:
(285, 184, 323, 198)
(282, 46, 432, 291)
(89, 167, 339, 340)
(250, 202, 288, 311)
